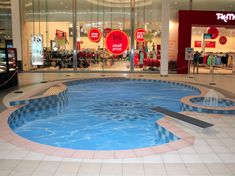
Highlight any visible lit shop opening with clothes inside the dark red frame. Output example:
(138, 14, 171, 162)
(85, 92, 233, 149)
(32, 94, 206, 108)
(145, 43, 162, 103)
(190, 26, 235, 74)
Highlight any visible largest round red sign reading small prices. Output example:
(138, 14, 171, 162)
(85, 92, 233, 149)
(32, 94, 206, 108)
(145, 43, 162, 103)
(105, 30, 129, 55)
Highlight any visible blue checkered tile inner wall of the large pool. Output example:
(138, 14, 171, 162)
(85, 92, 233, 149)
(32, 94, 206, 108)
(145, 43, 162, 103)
(8, 78, 200, 151)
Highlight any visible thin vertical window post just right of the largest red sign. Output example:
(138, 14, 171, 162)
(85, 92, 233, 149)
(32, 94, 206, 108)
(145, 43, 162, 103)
(130, 0, 135, 72)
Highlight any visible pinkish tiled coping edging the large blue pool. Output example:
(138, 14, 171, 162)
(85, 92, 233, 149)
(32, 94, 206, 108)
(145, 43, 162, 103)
(0, 78, 200, 159)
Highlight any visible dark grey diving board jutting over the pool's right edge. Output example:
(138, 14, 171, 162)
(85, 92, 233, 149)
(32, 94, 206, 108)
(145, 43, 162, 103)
(152, 106, 214, 129)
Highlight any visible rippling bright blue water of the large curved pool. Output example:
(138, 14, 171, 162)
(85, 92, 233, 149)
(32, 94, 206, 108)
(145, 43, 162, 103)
(14, 80, 199, 150)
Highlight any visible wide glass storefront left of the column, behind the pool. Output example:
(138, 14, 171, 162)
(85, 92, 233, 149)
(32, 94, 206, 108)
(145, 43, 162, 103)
(21, 0, 161, 71)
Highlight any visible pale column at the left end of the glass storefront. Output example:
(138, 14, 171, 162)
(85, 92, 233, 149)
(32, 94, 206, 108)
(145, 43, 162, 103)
(11, 0, 22, 61)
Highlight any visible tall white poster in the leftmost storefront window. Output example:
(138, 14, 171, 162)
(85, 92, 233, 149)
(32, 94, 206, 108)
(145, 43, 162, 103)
(32, 35, 43, 65)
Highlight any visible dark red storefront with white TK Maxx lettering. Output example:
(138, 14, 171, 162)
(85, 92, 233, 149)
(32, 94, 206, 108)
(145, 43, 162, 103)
(177, 10, 235, 74)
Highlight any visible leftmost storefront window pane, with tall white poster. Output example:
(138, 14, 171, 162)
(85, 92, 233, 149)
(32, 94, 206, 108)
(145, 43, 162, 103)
(21, 0, 73, 70)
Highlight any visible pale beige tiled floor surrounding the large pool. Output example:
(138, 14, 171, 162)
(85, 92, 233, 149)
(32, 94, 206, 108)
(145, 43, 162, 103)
(0, 73, 235, 176)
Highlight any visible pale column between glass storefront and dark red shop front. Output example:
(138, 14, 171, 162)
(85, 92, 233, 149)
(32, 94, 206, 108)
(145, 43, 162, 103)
(160, 0, 170, 76)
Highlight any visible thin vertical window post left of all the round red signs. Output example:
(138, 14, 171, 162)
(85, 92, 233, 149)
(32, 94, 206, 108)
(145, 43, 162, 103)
(73, 0, 78, 71)
